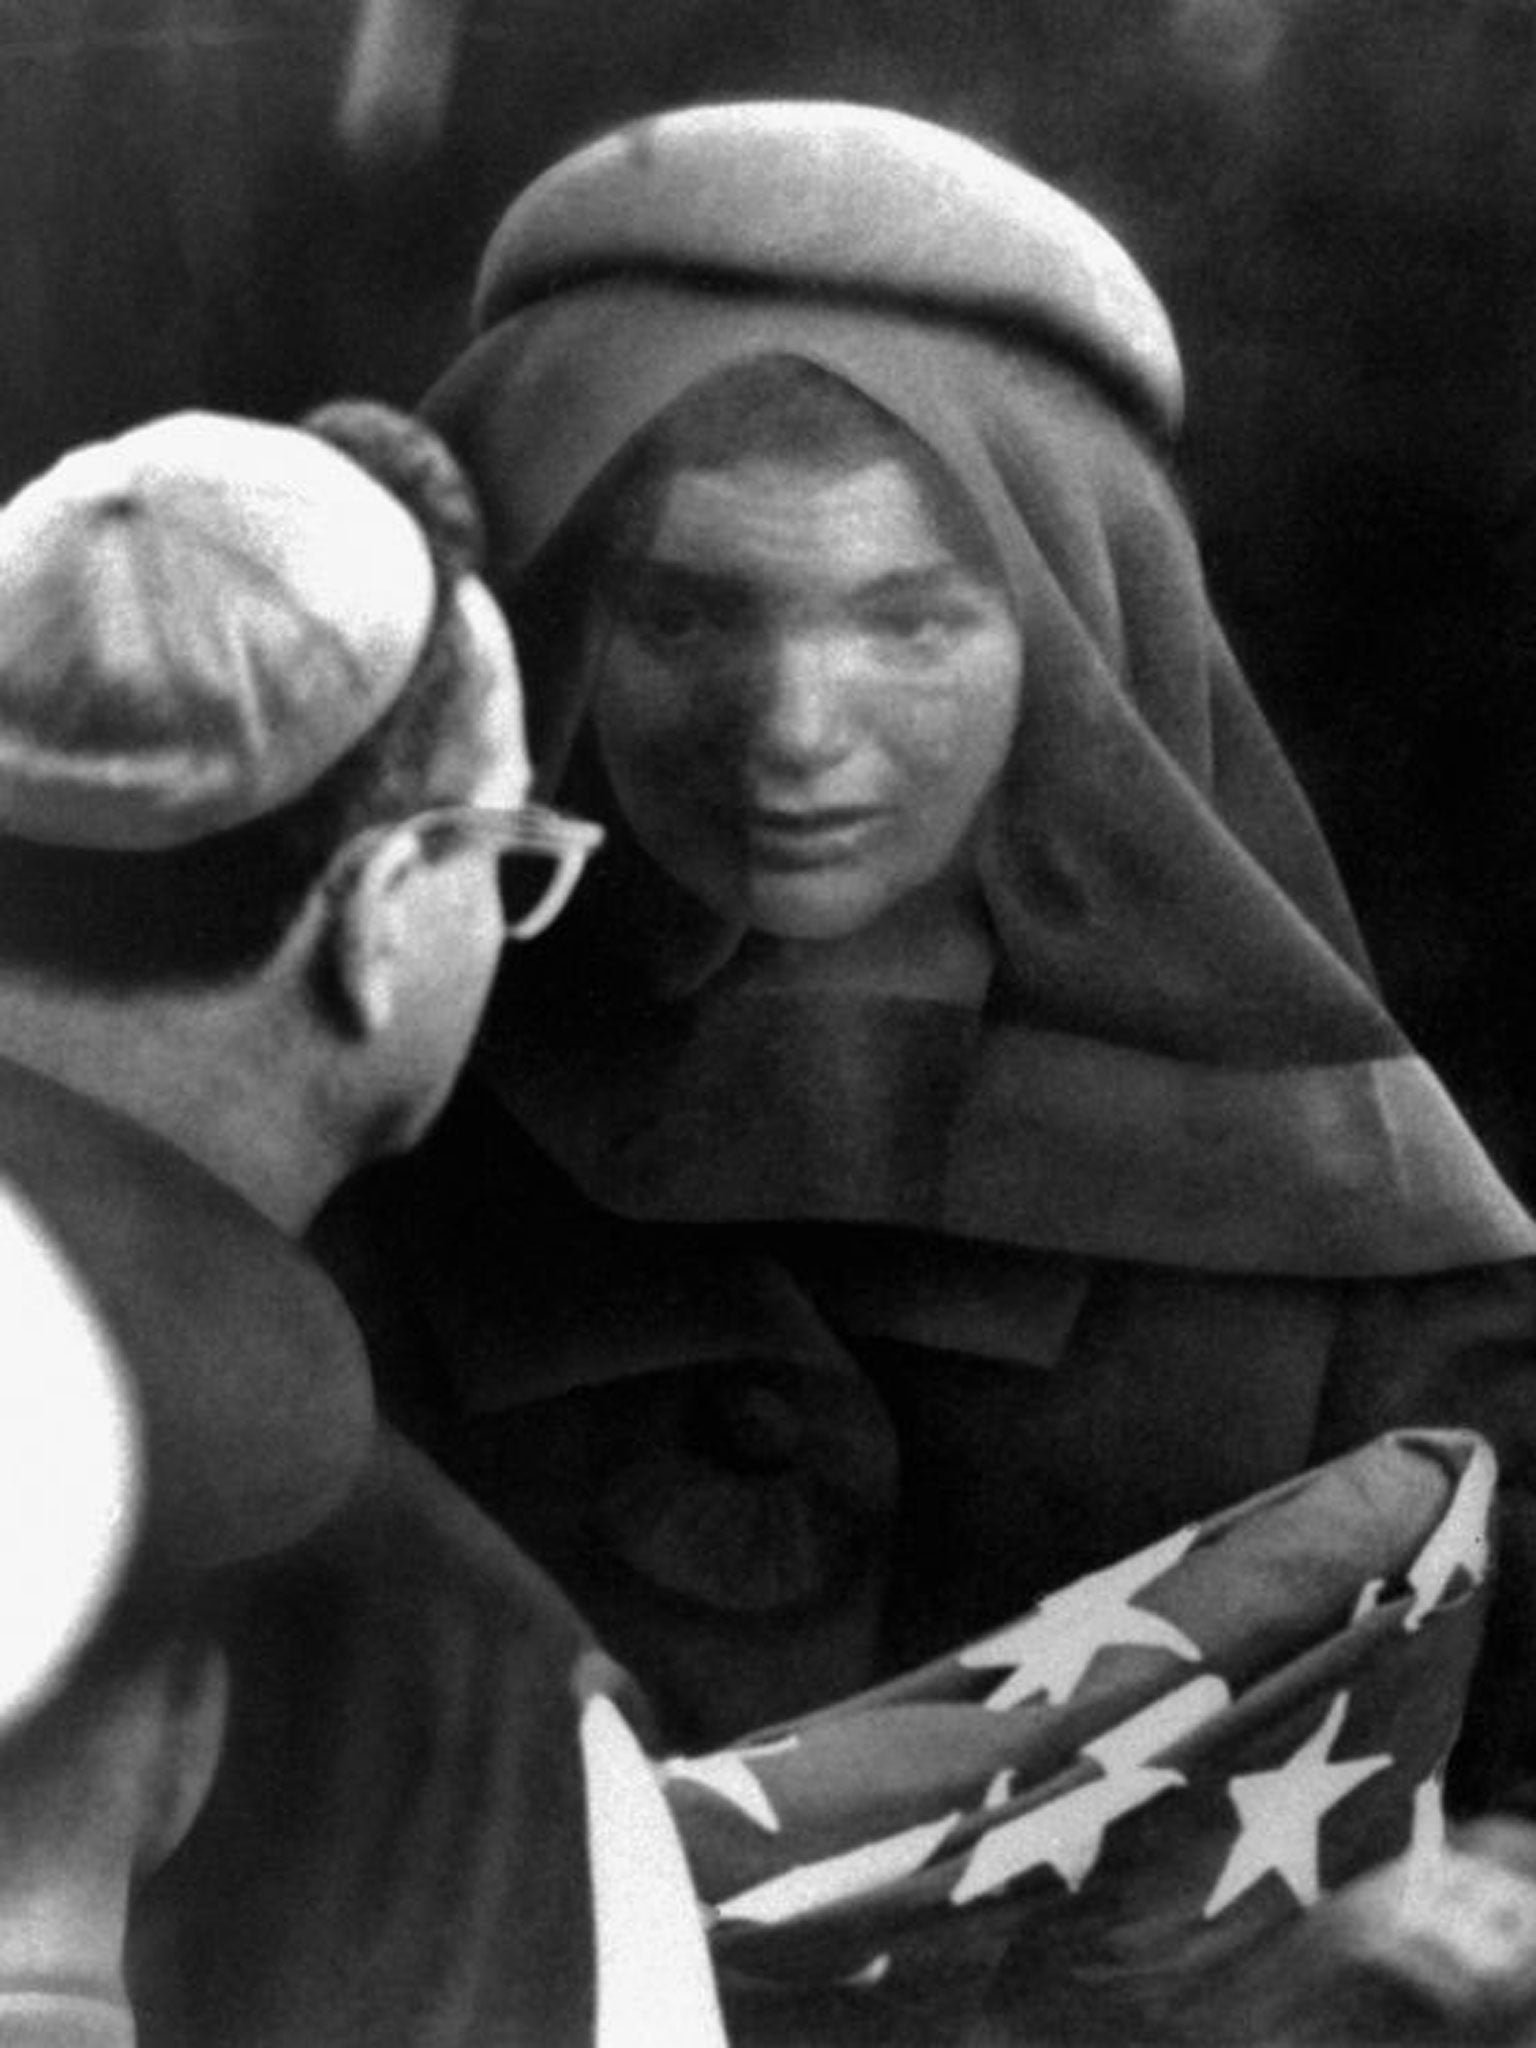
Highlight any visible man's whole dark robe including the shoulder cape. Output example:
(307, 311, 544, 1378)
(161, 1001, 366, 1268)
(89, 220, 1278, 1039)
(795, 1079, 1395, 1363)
(0, 1061, 651, 2048)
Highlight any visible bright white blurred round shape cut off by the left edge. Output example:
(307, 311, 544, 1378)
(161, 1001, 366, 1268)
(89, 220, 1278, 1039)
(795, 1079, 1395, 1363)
(0, 1182, 141, 1733)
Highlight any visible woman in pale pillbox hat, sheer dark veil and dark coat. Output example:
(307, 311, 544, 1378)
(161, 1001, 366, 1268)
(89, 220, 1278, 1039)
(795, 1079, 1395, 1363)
(319, 102, 1536, 1798)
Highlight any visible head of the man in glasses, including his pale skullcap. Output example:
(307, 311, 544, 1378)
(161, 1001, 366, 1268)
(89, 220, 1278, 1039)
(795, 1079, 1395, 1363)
(0, 403, 593, 1204)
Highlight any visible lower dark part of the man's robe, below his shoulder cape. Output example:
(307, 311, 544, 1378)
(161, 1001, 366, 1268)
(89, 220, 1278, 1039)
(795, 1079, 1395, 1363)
(129, 1434, 610, 2048)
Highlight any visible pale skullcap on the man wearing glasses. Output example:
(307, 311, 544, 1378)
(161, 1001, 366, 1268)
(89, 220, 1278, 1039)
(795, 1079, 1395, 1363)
(0, 412, 436, 850)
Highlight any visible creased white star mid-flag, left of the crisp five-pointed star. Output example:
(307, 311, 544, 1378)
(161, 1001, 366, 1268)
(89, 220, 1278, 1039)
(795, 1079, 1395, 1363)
(950, 1675, 1231, 1907)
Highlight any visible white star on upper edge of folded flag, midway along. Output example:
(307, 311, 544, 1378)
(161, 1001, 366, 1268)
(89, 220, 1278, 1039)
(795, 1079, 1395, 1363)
(958, 1526, 1200, 1714)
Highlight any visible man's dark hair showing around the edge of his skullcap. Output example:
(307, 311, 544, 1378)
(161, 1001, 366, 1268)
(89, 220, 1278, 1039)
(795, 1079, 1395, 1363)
(0, 401, 493, 989)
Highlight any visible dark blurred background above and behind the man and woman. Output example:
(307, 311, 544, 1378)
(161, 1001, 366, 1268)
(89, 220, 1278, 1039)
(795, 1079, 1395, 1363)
(0, 0, 1536, 1196)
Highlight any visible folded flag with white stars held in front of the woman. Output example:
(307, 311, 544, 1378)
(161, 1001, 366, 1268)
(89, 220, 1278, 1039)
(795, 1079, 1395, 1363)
(664, 1432, 1495, 2048)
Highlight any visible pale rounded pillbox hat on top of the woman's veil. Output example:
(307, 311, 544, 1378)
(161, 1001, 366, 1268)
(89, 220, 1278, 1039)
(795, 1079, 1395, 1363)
(475, 100, 1184, 432)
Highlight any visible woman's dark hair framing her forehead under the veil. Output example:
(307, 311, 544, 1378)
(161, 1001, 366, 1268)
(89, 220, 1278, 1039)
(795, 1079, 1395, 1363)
(506, 354, 1004, 795)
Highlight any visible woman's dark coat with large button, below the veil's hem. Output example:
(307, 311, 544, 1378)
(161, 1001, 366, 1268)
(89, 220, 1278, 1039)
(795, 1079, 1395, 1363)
(324, 1079, 1536, 1804)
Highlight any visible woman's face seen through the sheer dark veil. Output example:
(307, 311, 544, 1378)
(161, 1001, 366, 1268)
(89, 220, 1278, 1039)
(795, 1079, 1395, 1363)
(588, 455, 1022, 940)
